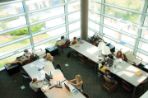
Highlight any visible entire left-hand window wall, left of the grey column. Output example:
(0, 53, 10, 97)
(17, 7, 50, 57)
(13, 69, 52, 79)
(0, 0, 80, 68)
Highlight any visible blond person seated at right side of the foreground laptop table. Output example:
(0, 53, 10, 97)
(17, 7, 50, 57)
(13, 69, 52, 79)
(69, 74, 83, 91)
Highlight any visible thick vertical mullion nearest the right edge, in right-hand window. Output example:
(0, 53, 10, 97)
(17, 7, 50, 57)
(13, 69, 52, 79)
(134, 0, 148, 54)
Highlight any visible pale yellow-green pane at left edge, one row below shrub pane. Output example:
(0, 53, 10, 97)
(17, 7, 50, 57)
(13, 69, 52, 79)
(0, 39, 30, 55)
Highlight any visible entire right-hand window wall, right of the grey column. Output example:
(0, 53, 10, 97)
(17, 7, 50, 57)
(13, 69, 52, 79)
(89, 0, 148, 62)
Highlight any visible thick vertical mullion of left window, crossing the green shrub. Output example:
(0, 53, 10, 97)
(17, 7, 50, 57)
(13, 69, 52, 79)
(22, 1, 34, 51)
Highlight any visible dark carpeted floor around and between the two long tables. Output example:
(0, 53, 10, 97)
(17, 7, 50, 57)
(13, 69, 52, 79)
(0, 49, 147, 98)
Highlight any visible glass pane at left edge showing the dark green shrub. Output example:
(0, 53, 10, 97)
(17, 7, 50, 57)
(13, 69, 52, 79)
(0, 28, 29, 44)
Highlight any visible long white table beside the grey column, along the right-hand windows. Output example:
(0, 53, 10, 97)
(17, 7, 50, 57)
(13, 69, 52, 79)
(70, 40, 148, 95)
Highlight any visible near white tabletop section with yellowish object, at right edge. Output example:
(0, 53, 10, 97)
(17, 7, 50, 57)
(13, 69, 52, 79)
(110, 59, 148, 87)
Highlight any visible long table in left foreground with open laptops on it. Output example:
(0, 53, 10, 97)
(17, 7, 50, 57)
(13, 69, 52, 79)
(23, 59, 85, 98)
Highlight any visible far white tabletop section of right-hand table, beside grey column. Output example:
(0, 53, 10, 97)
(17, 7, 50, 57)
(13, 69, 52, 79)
(70, 40, 99, 63)
